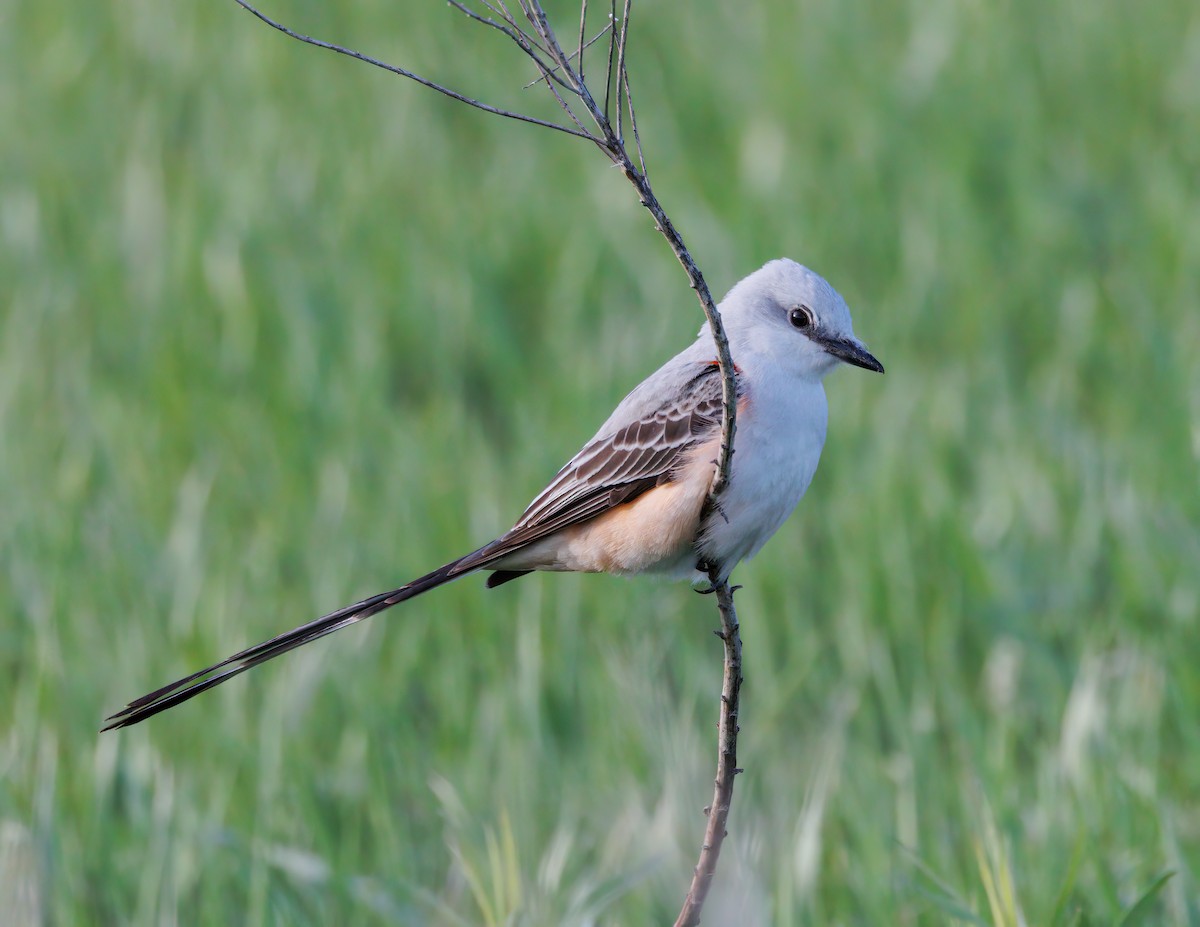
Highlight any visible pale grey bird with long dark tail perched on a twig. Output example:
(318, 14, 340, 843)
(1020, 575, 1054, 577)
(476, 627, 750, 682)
(102, 258, 883, 730)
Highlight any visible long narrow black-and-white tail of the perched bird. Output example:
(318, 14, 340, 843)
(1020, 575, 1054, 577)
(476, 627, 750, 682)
(101, 548, 484, 732)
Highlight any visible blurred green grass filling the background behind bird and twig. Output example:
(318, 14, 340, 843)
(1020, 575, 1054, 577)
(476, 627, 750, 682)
(0, 0, 1200, 927)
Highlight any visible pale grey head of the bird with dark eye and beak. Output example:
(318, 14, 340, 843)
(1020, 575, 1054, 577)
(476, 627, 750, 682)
(701, 258, 883, 378)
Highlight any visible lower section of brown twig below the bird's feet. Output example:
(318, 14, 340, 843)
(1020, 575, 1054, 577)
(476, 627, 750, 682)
(676, 567, 742, 927)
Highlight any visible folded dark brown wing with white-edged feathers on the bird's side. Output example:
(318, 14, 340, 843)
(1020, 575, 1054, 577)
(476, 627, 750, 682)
(457, 363, 721, 572)
